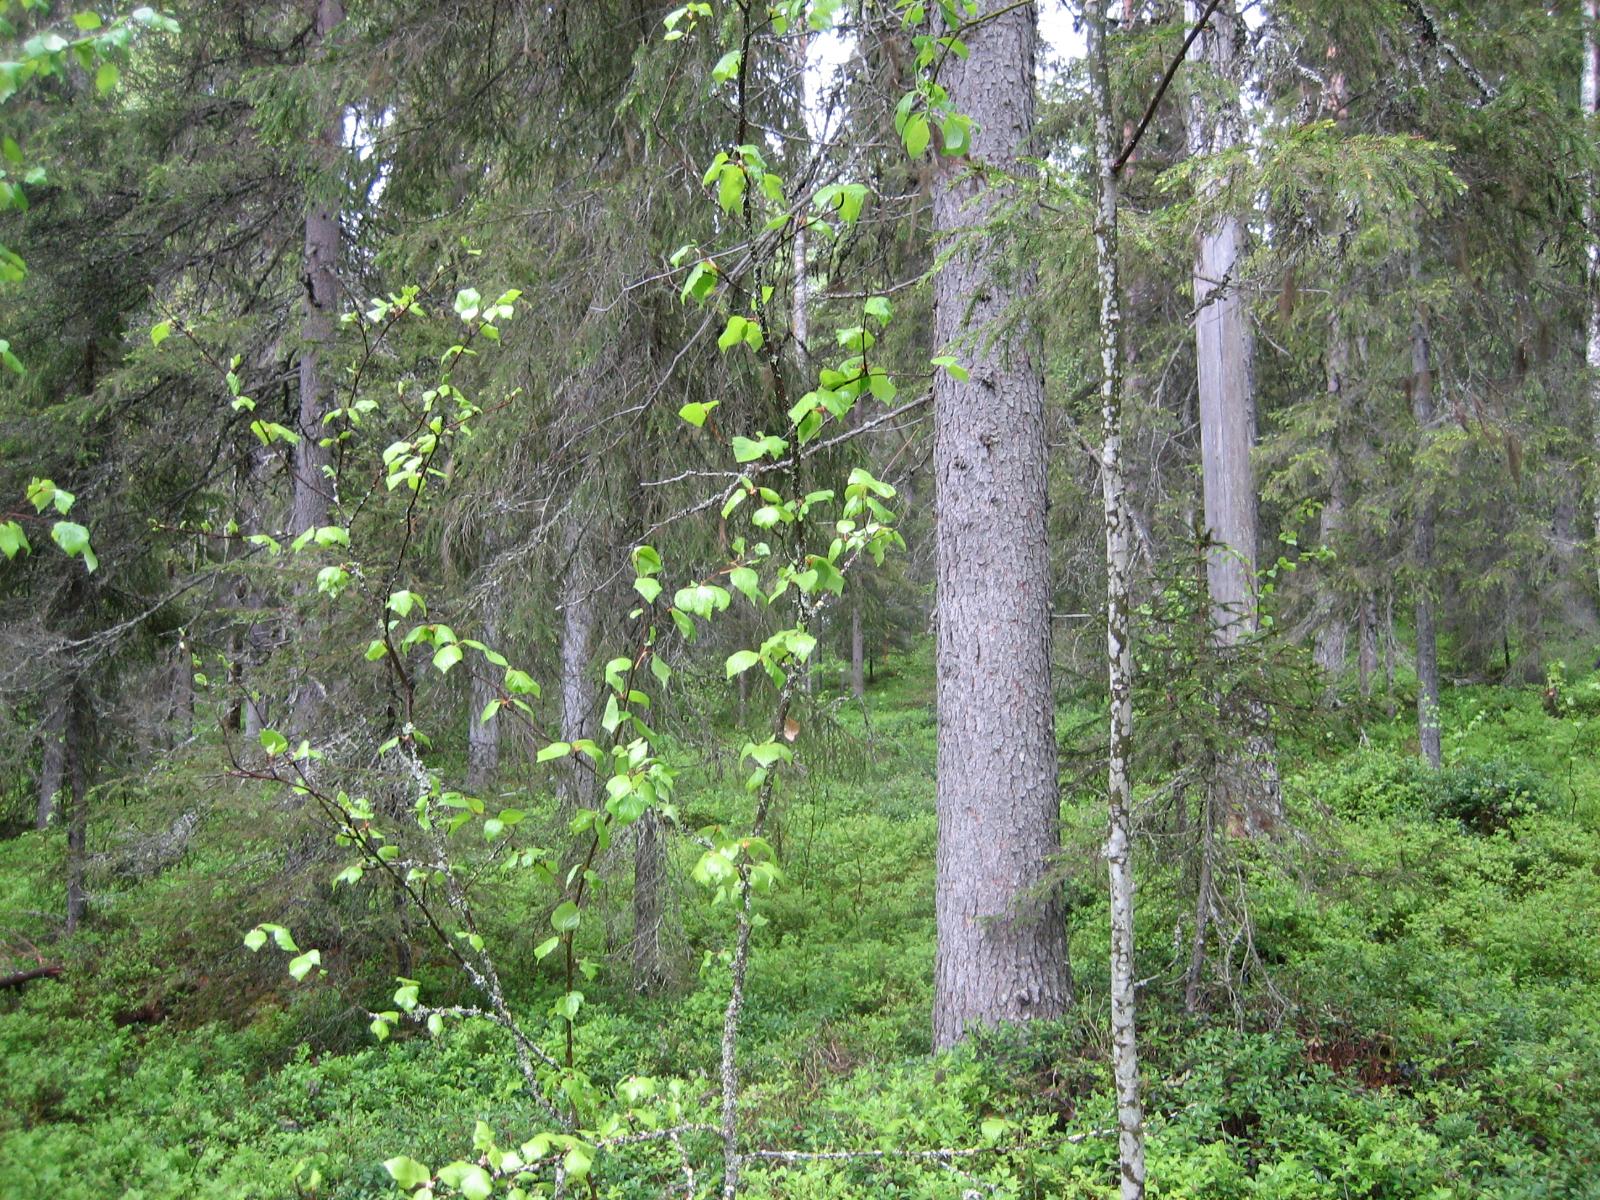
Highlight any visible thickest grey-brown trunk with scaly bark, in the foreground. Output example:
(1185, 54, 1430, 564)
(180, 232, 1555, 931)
(933, 0, 1070, 1048)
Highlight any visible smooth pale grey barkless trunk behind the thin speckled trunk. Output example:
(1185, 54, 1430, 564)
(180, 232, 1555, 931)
(1187, 0, 1283, 835)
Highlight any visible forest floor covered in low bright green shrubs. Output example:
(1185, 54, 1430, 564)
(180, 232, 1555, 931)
(0, 650, 1600, 1200)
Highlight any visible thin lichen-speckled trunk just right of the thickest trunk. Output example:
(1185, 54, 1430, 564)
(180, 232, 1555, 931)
(1083, 0, 1144, 1200)
